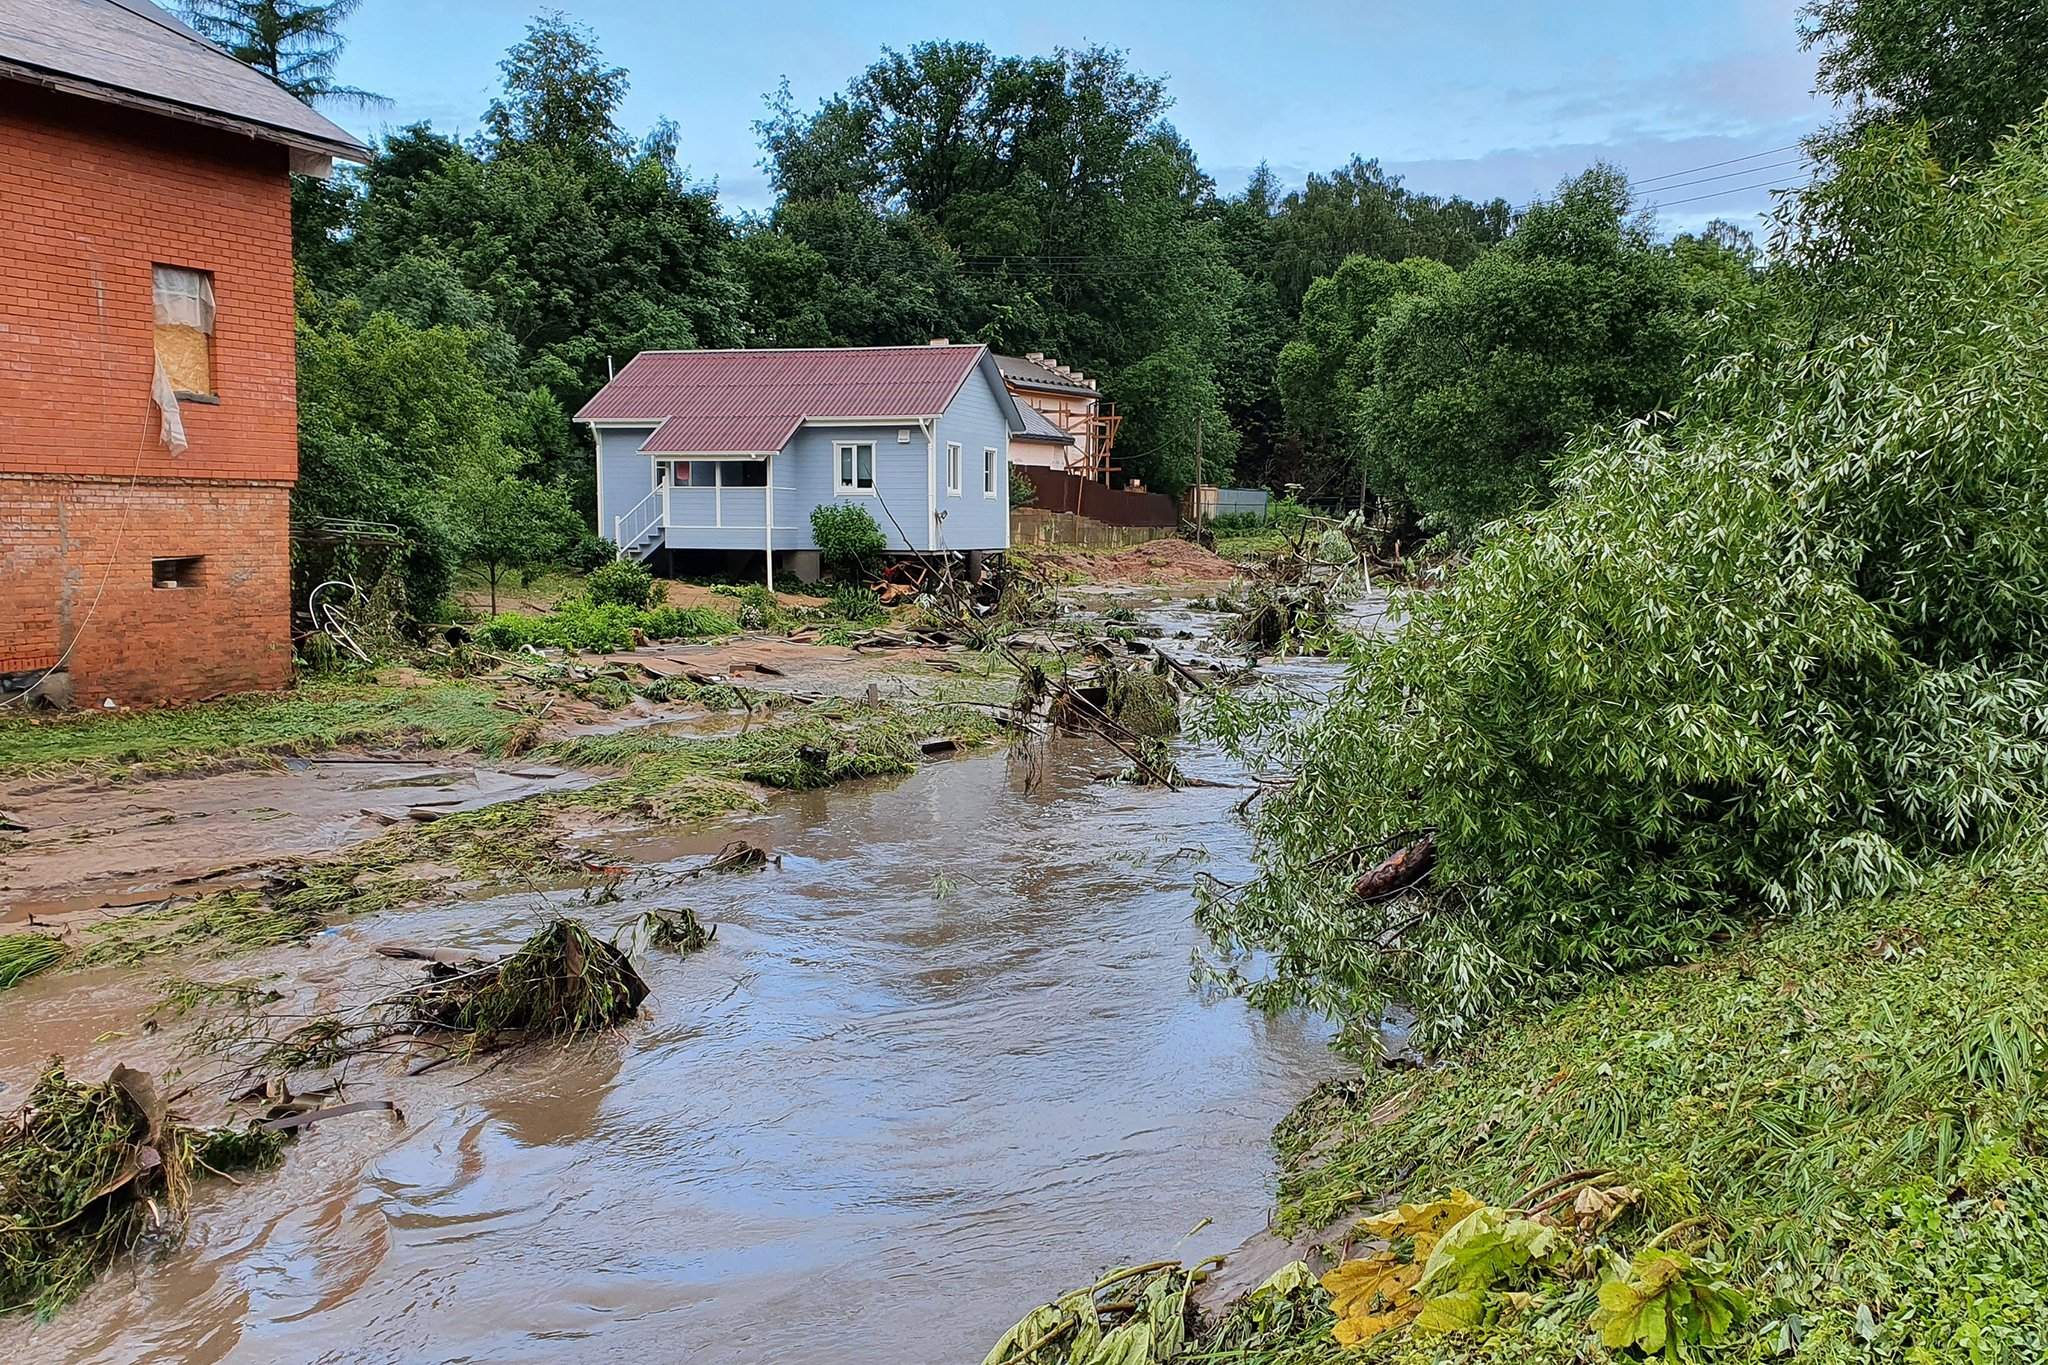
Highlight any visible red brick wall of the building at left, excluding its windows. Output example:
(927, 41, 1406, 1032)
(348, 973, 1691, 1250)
(0, 80, 297, 704)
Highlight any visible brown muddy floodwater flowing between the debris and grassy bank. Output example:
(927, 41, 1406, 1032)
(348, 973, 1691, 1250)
(0, 712, 1339, 1365)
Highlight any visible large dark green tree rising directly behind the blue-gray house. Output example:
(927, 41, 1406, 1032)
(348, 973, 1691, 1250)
(761, 43, 1236, 487)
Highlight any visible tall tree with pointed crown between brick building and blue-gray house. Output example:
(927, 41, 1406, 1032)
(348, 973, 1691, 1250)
(342, 14, 745, 514)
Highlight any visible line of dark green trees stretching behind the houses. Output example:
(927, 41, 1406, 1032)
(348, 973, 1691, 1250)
(188, 0, 2036, 596)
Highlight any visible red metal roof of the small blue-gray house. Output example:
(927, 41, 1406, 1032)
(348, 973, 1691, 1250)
(575, 346, 983, 454)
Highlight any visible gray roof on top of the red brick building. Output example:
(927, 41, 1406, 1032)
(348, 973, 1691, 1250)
(0, 0, 369, 162)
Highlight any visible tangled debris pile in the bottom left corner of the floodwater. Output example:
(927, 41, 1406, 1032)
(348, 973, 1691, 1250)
(0, 1058, 283, 1318)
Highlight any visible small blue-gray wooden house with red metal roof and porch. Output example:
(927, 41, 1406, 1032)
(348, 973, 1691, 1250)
(575, 342, 1026, 583)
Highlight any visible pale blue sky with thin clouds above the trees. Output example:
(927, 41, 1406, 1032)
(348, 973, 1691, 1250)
(327, 0, 1829, 229)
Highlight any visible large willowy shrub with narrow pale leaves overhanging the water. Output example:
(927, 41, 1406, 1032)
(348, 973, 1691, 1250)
(1202, 127, 2048, 1042)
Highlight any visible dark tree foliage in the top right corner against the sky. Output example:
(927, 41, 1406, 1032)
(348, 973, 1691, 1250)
(1800, 0, 2048, 164)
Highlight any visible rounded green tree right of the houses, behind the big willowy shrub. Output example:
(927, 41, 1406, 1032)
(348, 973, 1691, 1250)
(1356, 168, 1694, 536)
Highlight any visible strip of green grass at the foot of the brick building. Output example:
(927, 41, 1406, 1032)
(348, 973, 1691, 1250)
(0, 681, 520, 776)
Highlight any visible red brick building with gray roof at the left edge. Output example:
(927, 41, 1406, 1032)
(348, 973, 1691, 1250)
(0, 0, 367, 706)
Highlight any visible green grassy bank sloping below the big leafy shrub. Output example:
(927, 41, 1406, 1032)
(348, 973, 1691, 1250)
(1194, 864, 2048, 1365)
